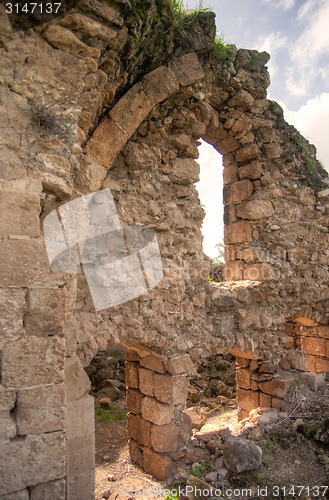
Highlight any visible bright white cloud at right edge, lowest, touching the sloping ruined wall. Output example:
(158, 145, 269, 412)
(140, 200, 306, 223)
(280, 92, 329, 171)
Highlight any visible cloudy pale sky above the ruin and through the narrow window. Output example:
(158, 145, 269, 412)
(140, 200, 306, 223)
(184, 0, 329, 257)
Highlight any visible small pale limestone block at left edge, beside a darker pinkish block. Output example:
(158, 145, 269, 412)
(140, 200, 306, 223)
(0, 288, 26, 339)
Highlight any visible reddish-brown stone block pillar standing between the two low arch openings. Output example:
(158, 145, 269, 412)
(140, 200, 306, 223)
(125, 346, 193, 480)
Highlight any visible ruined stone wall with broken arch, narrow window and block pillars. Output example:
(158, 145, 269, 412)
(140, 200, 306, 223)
(0, 0, 329, 500)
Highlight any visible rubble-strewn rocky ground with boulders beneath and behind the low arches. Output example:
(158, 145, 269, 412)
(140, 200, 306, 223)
(89, 353, 329, 500)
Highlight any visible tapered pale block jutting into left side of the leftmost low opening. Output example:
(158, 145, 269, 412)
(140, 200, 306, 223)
(64, 356, 91, 403)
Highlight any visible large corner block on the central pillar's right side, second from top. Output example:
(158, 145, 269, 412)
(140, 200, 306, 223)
(154, 373, 189, 406)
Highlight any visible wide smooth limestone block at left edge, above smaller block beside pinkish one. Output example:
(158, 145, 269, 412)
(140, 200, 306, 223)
(0, 239, 66, 288)
